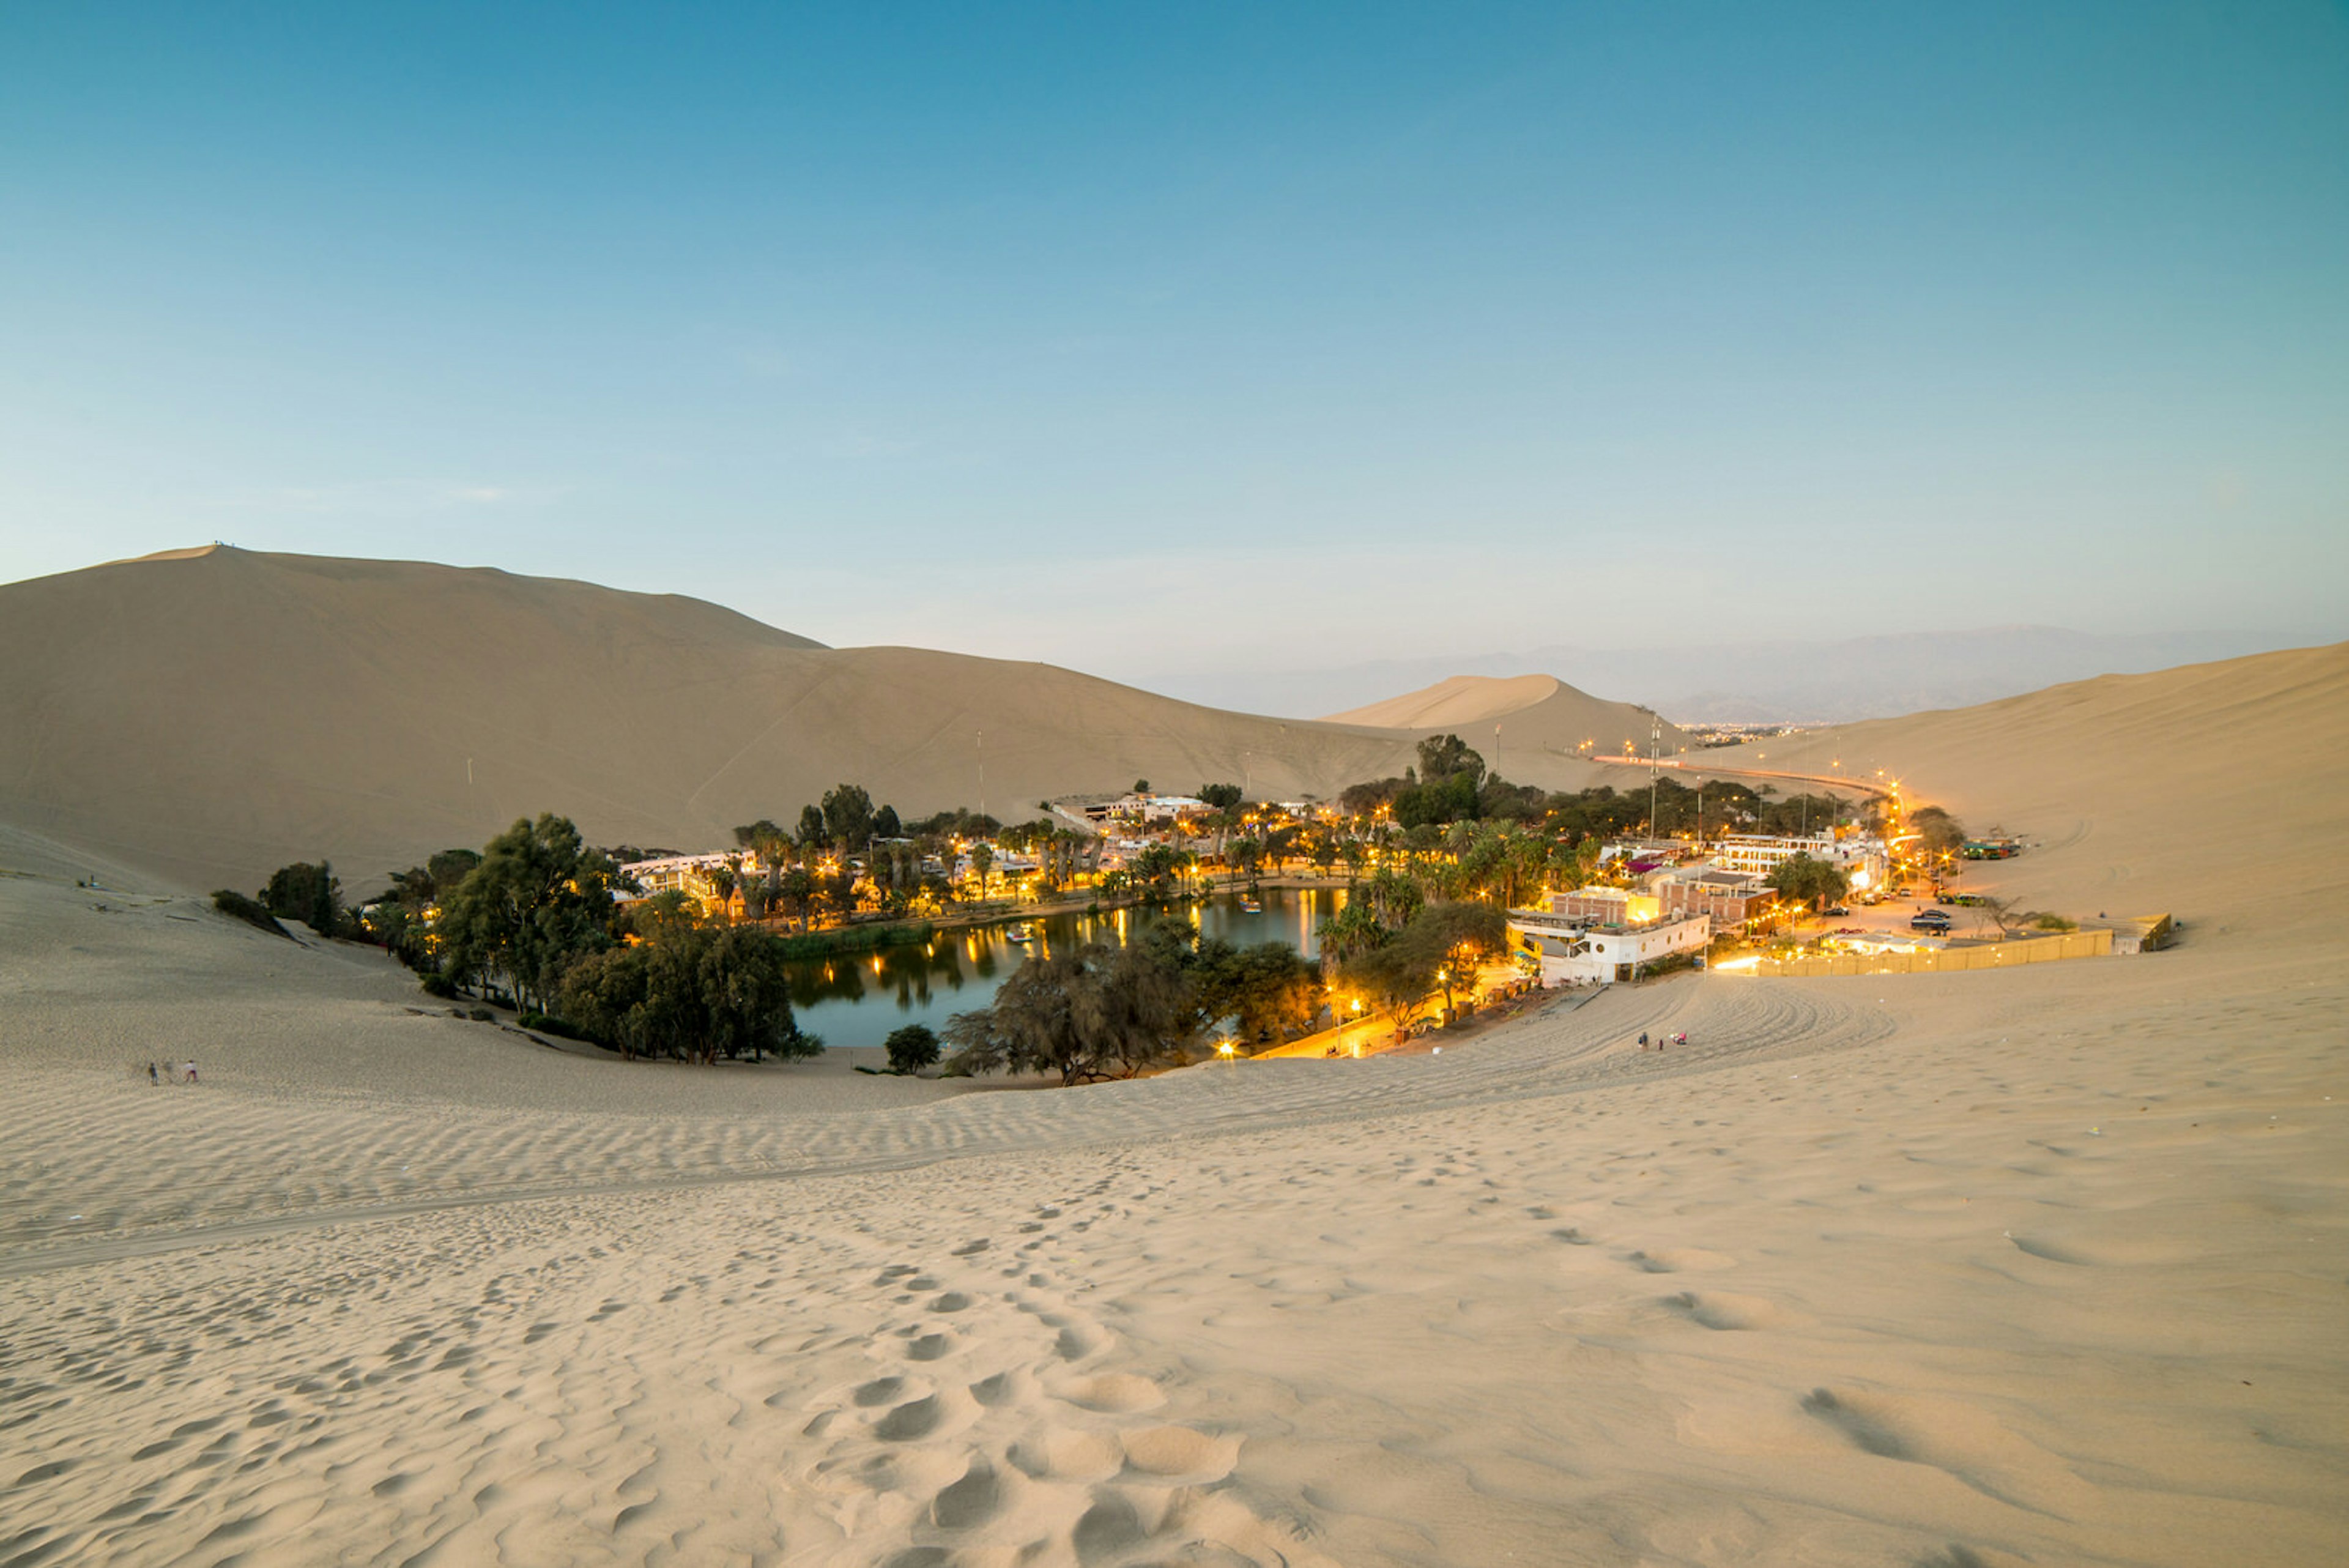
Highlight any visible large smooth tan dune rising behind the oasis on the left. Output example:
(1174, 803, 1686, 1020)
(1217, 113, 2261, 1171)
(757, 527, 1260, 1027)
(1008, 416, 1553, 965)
(0, 548, 1635, 888)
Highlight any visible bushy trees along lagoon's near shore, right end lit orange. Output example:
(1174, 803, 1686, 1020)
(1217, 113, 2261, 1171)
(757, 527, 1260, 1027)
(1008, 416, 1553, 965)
(949, 921, 1320, 1083)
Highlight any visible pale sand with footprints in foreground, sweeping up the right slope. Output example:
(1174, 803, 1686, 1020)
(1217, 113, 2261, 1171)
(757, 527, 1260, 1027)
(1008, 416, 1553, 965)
(0, 649, 2349, 1568)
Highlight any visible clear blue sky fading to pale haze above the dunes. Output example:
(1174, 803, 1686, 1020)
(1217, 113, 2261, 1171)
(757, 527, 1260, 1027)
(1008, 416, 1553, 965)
(0, 0, 2349, 691)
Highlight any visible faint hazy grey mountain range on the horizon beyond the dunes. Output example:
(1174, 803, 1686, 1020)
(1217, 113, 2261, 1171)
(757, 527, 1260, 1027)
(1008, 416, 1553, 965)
(1153, 625, 2340, 724)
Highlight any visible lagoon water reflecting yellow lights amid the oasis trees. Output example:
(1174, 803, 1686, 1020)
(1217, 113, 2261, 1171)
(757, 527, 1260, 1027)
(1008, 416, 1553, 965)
(792, 886, 1346, 1046)
